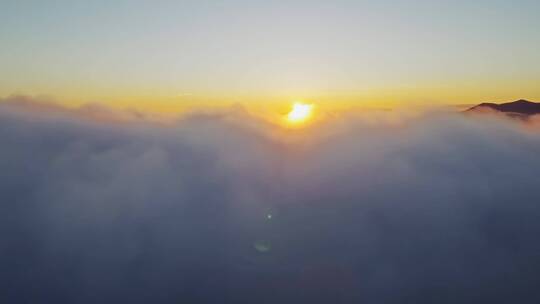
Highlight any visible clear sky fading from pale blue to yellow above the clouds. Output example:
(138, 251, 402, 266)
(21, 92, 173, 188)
(0, 0, 540, 110)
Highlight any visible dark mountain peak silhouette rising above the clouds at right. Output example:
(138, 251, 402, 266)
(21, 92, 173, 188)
(465, 99, 540, 118)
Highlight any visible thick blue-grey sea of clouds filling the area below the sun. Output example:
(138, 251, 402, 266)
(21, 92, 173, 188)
(0, 98, 540, 304)
